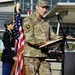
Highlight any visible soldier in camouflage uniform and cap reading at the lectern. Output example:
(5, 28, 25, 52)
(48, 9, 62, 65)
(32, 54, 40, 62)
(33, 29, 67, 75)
(23, 0, 59, 75)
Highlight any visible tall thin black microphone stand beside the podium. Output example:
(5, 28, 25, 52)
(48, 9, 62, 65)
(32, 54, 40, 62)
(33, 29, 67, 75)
(57, 18, 68, 75)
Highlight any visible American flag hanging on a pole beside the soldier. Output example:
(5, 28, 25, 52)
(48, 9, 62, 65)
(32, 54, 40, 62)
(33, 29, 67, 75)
(13, 4, 24, 75)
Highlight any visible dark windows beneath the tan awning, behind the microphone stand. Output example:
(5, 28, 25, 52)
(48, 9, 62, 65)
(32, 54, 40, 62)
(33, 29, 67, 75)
(52, 25, 75, 37)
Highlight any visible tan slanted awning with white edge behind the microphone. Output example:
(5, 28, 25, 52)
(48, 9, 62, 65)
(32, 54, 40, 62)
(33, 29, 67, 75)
(44, 2, 75, 24)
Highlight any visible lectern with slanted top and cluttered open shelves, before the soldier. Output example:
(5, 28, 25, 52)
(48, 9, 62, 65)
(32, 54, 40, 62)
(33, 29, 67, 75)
(40, 38, 64, 75)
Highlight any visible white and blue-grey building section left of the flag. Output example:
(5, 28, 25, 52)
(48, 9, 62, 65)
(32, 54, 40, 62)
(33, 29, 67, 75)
(0, 0, 14, 50)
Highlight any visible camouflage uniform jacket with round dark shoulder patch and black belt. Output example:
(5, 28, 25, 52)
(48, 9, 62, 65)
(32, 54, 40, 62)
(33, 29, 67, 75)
(23, 13, 59, 57)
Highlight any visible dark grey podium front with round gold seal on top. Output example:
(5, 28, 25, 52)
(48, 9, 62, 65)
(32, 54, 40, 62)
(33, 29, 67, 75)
(64, 38, 75, 75)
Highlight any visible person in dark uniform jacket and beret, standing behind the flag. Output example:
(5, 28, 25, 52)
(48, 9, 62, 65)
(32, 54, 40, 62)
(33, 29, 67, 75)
(1, 19, 18, 75)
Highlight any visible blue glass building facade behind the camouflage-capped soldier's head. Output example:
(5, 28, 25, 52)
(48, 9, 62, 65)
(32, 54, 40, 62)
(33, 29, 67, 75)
(19, 0, 75, 15)
